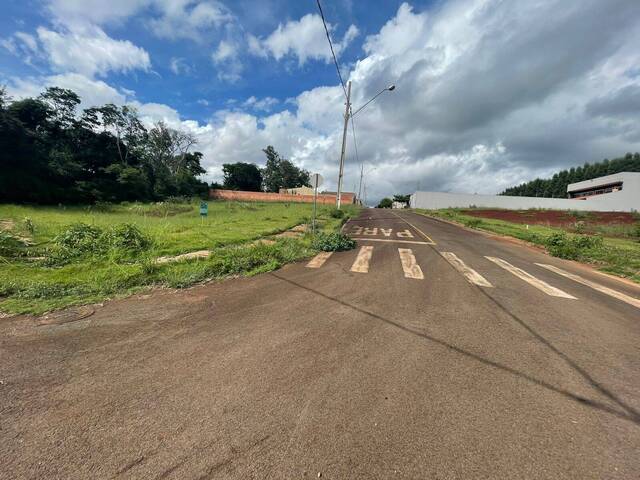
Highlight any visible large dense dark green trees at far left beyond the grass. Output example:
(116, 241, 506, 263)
(0, 87, 208, 203)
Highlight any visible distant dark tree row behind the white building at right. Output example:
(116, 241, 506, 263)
(500, 153, 640, 198)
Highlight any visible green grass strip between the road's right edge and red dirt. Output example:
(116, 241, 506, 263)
(416, 209, 640, 283)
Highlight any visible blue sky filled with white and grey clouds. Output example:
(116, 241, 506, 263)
(0, 0, 640, 200)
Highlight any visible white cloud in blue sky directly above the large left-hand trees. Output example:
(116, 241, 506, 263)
(37, 27, 151, 76)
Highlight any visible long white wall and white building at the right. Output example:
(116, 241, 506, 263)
(410, 172, 640, 212)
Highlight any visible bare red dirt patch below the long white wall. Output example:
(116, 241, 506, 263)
(464, 209, 637, 227)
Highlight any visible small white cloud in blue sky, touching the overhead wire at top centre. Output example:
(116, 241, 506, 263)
(252, 14, 358, 65)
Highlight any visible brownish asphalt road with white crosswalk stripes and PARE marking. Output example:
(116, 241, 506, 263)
(0, 210, 640, 479)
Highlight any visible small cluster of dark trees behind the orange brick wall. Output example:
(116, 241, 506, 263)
(211, 145, 311, 192)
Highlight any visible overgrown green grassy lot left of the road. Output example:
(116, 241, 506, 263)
(0, 201, 356, 314)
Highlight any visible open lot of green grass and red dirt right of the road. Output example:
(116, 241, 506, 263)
(417, 209, 640, 283)
